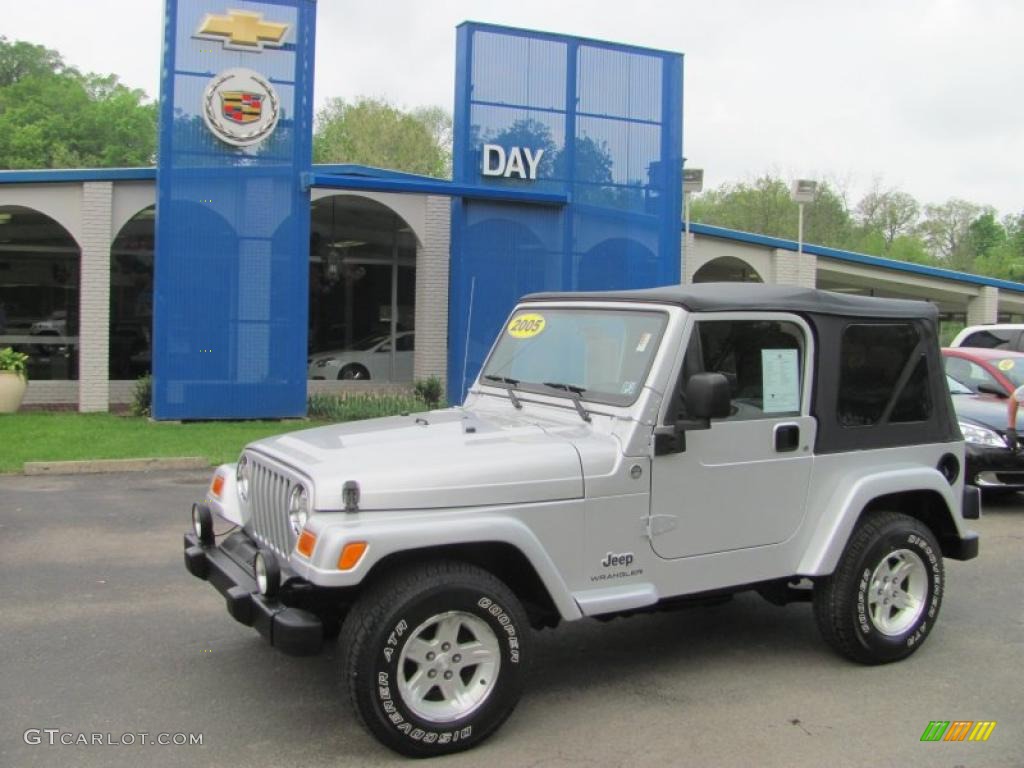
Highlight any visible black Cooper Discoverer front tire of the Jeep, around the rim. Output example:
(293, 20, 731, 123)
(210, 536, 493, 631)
(341, 560, 530, 758)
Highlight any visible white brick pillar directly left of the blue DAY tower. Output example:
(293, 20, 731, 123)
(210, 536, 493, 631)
(413, 195, 452, 391)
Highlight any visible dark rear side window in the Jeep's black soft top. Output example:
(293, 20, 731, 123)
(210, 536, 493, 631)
(836, 323, 932, 427)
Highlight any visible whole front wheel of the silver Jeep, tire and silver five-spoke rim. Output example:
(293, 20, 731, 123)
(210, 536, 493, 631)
(342, 561, 529, 757)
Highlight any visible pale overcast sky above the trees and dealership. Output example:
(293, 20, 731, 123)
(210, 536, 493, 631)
(0, 0, 1024, 214)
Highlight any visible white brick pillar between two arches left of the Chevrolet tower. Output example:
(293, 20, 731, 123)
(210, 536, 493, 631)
(78, 181, 114, 412)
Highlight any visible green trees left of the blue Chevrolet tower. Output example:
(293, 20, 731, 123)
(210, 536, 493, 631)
(0, 38, 157, 169)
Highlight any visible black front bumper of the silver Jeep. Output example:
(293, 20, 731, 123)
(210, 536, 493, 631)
(184, 531, 324, 656)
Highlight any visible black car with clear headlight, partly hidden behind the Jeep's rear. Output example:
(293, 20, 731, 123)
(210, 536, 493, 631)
(946, 376, 1024, 492)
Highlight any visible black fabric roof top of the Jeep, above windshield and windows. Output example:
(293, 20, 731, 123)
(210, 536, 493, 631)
(522, 283, 939, 321)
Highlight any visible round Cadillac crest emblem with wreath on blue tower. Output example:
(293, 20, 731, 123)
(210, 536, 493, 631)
(203, 68, 281, 146)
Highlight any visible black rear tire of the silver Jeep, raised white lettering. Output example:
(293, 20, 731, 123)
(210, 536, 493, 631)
(814, 512, 945, 665)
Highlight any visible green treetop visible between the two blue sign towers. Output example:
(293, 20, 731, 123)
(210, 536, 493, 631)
(313, 98, 452, 177)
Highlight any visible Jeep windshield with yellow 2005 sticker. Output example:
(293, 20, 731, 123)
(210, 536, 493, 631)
(480, 307, 668, 406)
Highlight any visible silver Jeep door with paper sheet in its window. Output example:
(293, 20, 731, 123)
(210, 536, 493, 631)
(650, 312, 816, 558)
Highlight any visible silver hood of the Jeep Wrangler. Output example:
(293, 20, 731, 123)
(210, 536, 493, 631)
(249, 409, 584, 510)
